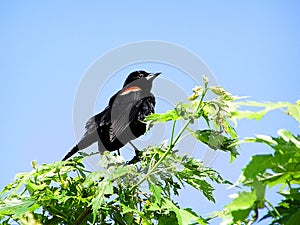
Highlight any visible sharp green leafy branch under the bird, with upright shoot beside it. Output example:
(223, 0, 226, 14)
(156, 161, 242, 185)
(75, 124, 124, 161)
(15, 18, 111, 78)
(0, 75, 236, 225)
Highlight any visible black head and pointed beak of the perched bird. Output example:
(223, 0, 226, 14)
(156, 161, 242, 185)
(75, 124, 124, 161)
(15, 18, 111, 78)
(123, 70, 161, 90)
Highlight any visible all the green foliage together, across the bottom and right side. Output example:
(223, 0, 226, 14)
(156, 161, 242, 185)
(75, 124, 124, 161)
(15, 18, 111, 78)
(0, 77, 300, 225)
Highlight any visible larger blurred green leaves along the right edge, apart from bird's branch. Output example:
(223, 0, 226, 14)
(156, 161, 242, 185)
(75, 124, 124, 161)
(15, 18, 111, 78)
(219, 101, 300, 225)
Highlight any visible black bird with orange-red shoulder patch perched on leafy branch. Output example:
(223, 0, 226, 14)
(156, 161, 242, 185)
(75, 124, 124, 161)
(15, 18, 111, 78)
(63, 70, 160, 160)
